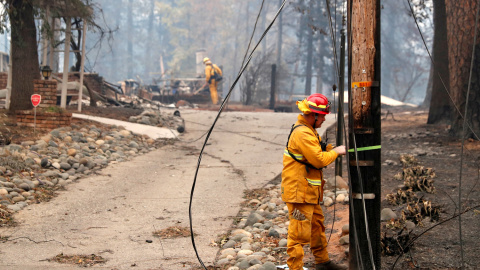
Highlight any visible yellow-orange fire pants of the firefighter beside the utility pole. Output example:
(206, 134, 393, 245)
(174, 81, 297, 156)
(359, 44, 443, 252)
(287, 203, 329, 270)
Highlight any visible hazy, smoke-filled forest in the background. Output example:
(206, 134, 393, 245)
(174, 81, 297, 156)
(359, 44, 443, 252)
(0, 0, 433, 104)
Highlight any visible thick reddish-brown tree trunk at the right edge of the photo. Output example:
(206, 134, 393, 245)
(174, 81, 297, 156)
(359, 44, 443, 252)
(445, 0, 480, 137)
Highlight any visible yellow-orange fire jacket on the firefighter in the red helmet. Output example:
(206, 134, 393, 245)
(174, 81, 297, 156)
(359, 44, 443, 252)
(281, 114, 338, 204)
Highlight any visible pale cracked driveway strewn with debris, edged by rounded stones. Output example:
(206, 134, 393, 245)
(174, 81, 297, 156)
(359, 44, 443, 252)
(0, 108, 338, 270)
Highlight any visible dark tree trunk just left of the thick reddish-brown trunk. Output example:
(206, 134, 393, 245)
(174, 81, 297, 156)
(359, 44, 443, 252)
(424, 0, 455, 124)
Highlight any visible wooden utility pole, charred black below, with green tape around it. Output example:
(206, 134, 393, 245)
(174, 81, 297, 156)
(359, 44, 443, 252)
(348, 0, 381, 269)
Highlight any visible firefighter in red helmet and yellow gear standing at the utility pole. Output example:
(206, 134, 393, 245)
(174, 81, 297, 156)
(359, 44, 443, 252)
(281, 94, 347, 270)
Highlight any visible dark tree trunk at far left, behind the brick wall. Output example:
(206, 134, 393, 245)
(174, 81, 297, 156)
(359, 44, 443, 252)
(8, 0, 40, 112)
